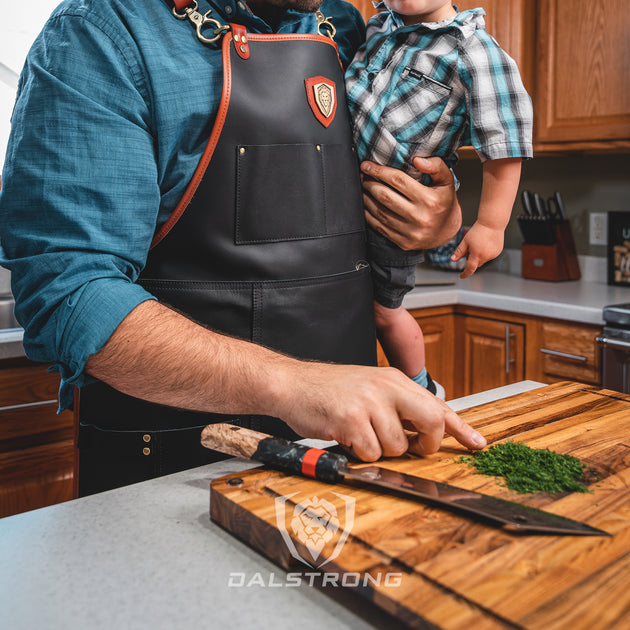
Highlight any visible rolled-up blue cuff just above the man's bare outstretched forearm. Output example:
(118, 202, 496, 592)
(52, 278, 156, 411)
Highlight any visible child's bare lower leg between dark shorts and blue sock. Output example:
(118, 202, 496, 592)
(374, 302, 425, 378)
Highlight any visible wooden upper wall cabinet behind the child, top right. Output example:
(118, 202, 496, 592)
(353, 0, 630, 154)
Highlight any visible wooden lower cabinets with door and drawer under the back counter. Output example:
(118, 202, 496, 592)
(402, 304, 601, 400)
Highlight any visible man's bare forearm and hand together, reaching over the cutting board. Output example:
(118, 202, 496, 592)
(86, 300, 485, 461)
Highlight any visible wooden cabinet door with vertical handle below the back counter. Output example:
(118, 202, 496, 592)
(460, 316, 525, 396)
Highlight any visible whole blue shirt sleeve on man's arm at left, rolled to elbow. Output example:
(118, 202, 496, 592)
(0, 13, 160, 408)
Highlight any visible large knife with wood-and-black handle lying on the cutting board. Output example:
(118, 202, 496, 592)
(201, 423, 610, 536)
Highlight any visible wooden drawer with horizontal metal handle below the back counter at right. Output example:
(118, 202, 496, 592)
(540, 322, 601, 385)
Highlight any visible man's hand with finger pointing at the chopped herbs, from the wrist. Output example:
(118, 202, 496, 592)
(276, 362, 486, 461)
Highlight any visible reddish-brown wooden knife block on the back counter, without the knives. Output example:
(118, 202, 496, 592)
(521, 220, 581, 282)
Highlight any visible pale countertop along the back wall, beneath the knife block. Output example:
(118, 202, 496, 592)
(403, 267, 630, 324)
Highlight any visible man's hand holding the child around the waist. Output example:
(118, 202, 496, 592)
(361, 158, 462, 250)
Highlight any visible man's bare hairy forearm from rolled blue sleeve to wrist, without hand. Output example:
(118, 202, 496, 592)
(86, 300, 297, 415)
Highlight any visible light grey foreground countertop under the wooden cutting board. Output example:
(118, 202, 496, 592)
(0, 381, 542, 630)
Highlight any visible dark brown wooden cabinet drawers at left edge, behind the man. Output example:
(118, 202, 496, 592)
(0, 359, 75, 517)
